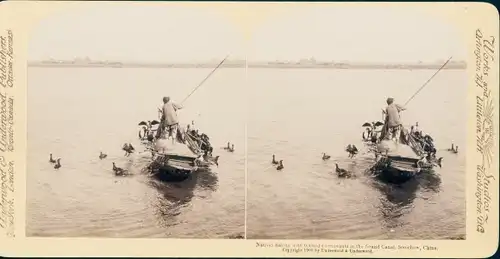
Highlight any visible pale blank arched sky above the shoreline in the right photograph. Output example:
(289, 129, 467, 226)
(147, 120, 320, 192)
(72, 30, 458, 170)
(249, 6, 467, 62)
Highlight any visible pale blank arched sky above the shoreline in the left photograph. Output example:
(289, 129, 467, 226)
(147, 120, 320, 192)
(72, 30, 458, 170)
(29, 2, 245, 62)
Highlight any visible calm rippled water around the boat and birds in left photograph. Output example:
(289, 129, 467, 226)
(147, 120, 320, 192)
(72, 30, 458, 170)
(27, 68, 245, 238)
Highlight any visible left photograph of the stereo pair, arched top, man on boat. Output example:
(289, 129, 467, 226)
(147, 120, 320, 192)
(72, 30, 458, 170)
(26, 2, 246, 239)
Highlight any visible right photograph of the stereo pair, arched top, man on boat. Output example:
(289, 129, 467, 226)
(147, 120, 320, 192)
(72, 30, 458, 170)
(246, 5, 468, 240)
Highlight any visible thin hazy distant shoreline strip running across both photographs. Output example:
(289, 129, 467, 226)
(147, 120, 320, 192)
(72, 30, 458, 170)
(28, 62, 467, 70)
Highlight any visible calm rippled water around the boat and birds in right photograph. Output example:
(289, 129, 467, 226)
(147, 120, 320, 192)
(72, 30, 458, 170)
(247, 69, 467, 239)
